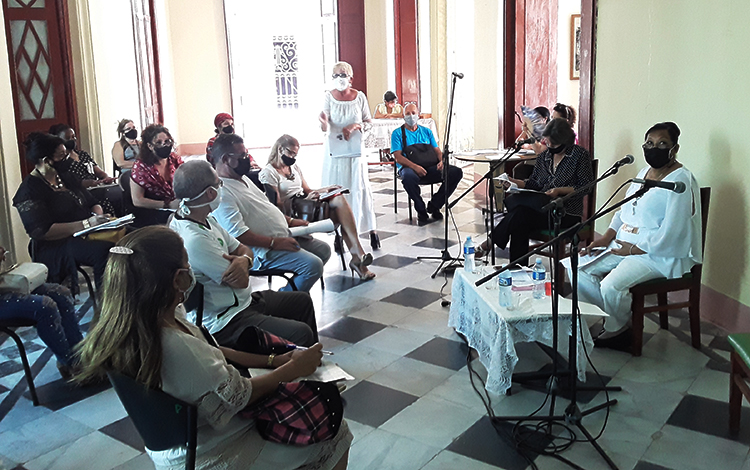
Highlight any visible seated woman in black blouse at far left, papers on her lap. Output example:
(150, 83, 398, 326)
(13, 132, 113, 294)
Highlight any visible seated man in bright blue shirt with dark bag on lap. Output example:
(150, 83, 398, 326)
(391, 103, 464, 223)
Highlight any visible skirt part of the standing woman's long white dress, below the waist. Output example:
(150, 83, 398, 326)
(321, 151, 376, 233)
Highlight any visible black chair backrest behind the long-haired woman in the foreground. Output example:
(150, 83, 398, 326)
(107, 372, 198, 468)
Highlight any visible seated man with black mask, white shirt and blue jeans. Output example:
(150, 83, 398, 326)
(212, 134, 331, 292)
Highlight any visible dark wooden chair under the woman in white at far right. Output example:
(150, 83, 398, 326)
(630, 188, 711, 356)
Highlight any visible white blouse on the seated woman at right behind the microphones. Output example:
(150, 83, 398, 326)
(609, 167, 703, 278)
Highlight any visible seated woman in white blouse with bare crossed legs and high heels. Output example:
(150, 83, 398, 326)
(259, 134, 375, 281)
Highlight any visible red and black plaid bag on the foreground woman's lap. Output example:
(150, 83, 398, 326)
(240, 381, 344, 446)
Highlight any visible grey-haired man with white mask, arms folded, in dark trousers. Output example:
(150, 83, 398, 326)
(169, 160, 318, 350)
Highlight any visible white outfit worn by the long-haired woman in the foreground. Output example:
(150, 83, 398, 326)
(146, 306, 352, 470)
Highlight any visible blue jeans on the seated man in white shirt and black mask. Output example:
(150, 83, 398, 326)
(253, 237, 331, 292)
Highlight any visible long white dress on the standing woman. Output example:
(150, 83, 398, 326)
(322, 91, 376, 233)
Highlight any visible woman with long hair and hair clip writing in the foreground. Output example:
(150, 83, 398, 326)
(78, 226, 352, 470)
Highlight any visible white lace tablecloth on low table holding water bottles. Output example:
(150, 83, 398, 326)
(448, 269, 605, 395)
